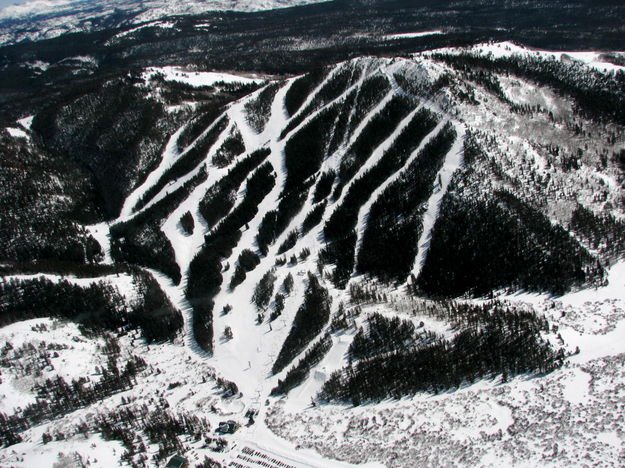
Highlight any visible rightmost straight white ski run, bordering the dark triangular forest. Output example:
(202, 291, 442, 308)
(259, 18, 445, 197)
(412, 123, 465, 278)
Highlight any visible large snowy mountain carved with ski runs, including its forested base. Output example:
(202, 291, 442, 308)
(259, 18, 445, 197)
(0, 43, 625, 467)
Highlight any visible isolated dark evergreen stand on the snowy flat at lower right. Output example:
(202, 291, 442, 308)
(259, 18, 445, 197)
(320, 303, 564, 405)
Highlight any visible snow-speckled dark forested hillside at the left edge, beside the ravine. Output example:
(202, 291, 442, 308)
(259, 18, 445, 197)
(0, 135, 102, 264)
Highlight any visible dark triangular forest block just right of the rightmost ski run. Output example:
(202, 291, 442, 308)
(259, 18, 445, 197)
(415, 179, 603, 296)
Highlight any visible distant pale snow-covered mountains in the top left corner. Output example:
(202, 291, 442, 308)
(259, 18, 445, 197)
(0, 0, 330, 44)
